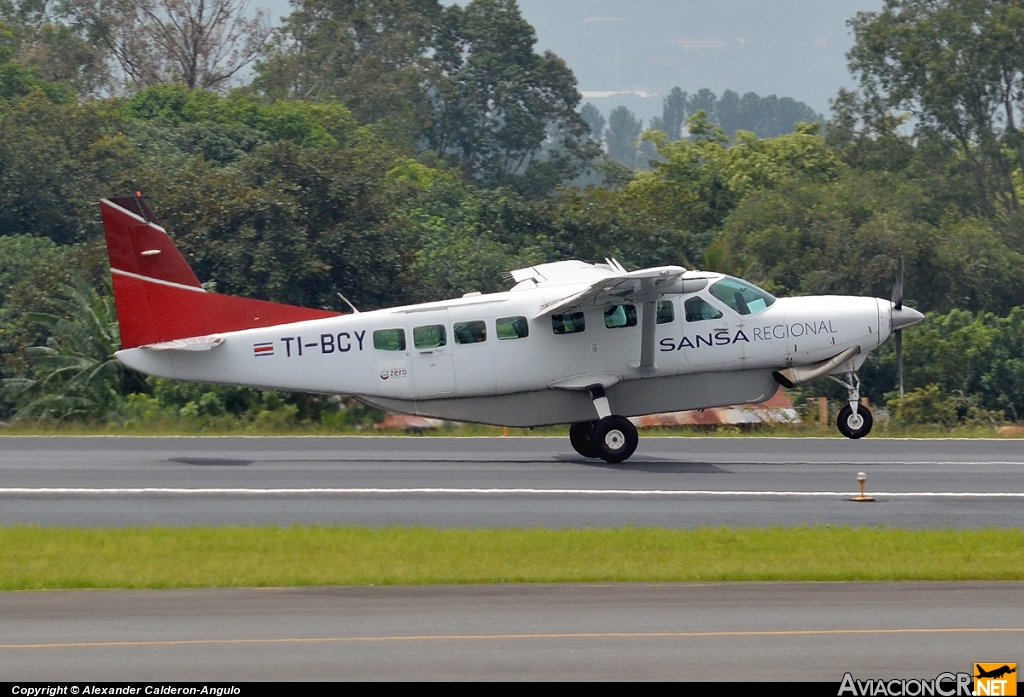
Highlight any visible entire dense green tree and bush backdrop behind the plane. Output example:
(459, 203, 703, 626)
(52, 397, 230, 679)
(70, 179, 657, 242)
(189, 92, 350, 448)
(0, 0, 1024, 423)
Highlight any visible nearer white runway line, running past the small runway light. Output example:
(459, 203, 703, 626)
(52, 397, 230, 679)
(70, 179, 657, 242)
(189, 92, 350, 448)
(0, 486, 1024, 498)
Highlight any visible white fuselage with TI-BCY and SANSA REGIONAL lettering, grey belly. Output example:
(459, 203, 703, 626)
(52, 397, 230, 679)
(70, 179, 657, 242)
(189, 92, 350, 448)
(117, 272, 892, 426)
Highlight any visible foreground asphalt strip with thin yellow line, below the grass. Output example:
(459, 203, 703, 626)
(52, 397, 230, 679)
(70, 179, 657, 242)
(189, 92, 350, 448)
(0, 583, 1024, 685)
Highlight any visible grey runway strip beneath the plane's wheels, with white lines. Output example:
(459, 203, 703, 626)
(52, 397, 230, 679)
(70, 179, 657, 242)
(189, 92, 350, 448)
(0, 437, 1024, 528)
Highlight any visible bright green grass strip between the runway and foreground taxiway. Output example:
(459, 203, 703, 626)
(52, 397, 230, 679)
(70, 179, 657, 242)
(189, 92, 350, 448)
(0, 526, 1024, 590)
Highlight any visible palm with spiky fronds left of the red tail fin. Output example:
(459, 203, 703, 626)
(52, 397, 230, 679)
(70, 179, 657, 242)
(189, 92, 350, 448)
(4, 281, 146, 420)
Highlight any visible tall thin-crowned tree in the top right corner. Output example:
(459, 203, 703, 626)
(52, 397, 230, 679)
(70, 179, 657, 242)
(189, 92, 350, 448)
(848, 0, 1024, 215)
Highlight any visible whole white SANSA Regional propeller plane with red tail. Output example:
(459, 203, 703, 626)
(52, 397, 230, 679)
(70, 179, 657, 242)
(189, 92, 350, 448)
(100, 195, 923, 463)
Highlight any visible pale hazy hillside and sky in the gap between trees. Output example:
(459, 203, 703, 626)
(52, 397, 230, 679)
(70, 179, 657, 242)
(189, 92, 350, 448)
(519, 0, 882, 122)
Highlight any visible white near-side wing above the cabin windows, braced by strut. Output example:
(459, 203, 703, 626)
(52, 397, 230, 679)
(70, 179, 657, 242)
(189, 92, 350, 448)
(534, 266, 688, 319)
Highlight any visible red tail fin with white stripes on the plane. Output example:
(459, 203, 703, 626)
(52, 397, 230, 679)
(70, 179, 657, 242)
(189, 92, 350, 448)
(100, 194, 338, 348)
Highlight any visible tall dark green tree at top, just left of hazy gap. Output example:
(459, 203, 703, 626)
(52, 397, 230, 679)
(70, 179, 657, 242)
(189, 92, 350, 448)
(428, 0, 598, 197)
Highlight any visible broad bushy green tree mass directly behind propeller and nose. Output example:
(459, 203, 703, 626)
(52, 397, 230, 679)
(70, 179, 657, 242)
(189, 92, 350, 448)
(720, 170, 1024, 311)
